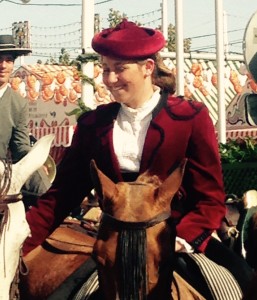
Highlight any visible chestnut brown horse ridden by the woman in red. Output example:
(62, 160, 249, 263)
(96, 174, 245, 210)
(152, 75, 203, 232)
(20, 161, 204, 300)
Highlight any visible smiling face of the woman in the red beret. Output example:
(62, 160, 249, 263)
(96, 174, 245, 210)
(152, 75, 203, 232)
(102, 56, 154, 108)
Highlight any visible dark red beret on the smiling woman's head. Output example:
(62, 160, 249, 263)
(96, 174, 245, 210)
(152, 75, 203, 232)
(92, 19, 165, 59)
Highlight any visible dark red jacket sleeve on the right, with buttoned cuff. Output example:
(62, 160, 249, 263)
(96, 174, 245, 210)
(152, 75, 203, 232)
(177, 107, 225, 252)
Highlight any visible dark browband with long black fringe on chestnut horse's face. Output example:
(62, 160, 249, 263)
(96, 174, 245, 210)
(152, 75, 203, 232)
(100, 212, 171, 300)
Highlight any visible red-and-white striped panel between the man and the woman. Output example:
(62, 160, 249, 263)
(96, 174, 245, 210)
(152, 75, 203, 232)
(30, 125, 75, 147)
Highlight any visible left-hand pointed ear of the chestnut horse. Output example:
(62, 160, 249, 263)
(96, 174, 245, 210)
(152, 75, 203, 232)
(90, 160, 116, 199)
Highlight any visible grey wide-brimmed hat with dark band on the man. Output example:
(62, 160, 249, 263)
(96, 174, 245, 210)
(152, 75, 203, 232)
(0, 34, 32, 56)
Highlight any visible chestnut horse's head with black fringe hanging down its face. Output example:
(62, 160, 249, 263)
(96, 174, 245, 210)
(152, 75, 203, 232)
(91, 160, 186, 300)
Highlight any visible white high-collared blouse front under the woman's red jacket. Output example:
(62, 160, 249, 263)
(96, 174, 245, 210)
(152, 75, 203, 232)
(113, 89, 160, 172)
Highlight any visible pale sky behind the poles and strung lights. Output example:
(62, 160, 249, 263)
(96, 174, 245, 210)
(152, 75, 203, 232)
(0, 0, 257, 64)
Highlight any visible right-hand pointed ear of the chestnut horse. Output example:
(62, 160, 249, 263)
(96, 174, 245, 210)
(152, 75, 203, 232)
(158, 159, 187, 201)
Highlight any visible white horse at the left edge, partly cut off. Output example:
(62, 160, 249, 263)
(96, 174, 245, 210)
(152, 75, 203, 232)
(0, 134, 54, 300)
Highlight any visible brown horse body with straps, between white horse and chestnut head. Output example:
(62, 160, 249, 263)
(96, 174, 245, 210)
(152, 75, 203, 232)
(20, 219, 95, 300)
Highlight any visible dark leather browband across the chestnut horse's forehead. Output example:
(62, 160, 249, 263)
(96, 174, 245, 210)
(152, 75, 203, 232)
(101, 212, 171, 231)
